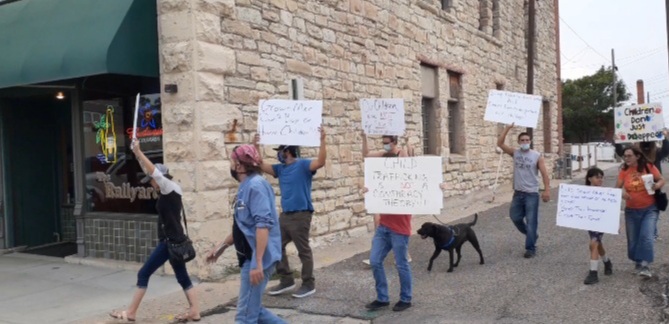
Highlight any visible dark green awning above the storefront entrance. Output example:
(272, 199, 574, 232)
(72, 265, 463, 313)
(0, 0, 159, 88)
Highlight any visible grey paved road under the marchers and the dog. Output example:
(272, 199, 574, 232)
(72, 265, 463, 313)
(264, 168, 669, 323)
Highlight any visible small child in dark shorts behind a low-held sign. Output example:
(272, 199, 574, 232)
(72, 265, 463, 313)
(583, 168, 613, 285)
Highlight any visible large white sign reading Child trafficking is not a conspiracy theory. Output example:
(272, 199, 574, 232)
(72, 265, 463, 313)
(365, 156, 444, 214)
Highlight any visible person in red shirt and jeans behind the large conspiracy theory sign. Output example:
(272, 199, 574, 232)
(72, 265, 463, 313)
(362, 132, 412, 311)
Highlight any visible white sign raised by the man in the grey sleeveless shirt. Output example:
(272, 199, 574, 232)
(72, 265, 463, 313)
(483, 90, 542, 128)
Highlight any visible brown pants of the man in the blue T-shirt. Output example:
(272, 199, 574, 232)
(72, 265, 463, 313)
(276, 211, 314, 289)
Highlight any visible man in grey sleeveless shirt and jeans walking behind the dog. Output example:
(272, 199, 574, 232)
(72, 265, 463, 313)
(497, 124, 551, 259)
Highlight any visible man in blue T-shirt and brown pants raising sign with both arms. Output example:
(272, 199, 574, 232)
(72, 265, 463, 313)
(254, 127, 327, 298)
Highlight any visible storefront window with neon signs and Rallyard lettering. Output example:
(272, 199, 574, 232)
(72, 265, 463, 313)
(83, 94, 163, 214)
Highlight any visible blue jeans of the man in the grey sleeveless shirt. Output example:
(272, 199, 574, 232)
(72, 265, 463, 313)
(509, 191, 539, 253)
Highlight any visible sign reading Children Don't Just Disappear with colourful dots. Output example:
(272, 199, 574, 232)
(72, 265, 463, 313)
(614, 103, 664, 143)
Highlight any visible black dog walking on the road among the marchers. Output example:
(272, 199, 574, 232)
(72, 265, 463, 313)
(418, 213, 484, 272)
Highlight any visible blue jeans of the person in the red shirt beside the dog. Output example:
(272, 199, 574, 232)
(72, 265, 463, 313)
(369, 225, 411, 303)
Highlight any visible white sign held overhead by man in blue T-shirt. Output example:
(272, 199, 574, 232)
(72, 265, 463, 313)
(258, 100, 323, 146)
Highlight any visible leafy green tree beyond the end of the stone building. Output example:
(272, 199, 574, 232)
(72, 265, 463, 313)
(562, 66, 630, 143)
